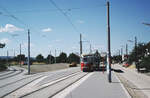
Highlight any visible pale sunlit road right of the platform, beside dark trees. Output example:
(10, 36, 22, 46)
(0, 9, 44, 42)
(112, 64, 150, 98)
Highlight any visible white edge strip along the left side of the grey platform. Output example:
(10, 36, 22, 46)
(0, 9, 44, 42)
(53, 73, 94, 98)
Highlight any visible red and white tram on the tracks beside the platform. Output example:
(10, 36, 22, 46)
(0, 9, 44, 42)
(81, 54, 100, 72)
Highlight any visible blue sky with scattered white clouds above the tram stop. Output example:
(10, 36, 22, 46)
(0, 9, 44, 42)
(0, 0, 150, 57)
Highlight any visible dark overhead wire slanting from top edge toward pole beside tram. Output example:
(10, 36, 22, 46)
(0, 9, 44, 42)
(49, 0, 79, 32)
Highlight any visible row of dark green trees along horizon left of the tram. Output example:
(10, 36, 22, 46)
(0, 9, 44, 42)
(0, 52, 80, 65)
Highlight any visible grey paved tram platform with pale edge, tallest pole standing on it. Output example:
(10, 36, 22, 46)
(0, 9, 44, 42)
(55, 72, 131, 98)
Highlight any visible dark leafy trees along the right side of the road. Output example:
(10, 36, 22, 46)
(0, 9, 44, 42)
(112, 42, 150, 71)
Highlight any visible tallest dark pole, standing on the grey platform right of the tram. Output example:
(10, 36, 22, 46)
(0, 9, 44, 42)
(107, 1, 111, 83)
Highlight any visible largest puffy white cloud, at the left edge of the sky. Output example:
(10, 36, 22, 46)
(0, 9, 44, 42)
(0, 24, 23, 33)
